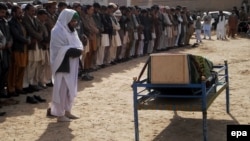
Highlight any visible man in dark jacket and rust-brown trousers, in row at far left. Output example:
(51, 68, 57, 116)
(8, 6, 30, 95)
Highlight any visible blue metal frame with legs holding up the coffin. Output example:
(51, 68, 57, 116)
(132, 61, 230, 141)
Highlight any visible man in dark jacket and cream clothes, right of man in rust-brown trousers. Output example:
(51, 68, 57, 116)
(22, 4, 43, 91)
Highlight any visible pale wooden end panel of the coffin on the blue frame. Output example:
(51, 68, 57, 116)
(148, 53, 190, 84)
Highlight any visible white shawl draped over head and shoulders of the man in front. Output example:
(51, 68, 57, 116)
(50, 9, 83, 73)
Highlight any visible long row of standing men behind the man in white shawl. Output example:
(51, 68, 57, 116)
(0, 2, 247, 116)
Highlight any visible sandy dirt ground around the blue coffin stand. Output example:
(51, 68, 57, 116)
(0, 36, 250, 141)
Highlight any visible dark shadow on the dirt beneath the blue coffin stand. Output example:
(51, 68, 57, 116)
(153, 113, 239, 141)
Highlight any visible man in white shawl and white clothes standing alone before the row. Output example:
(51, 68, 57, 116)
(49, 9, 83, 122)
